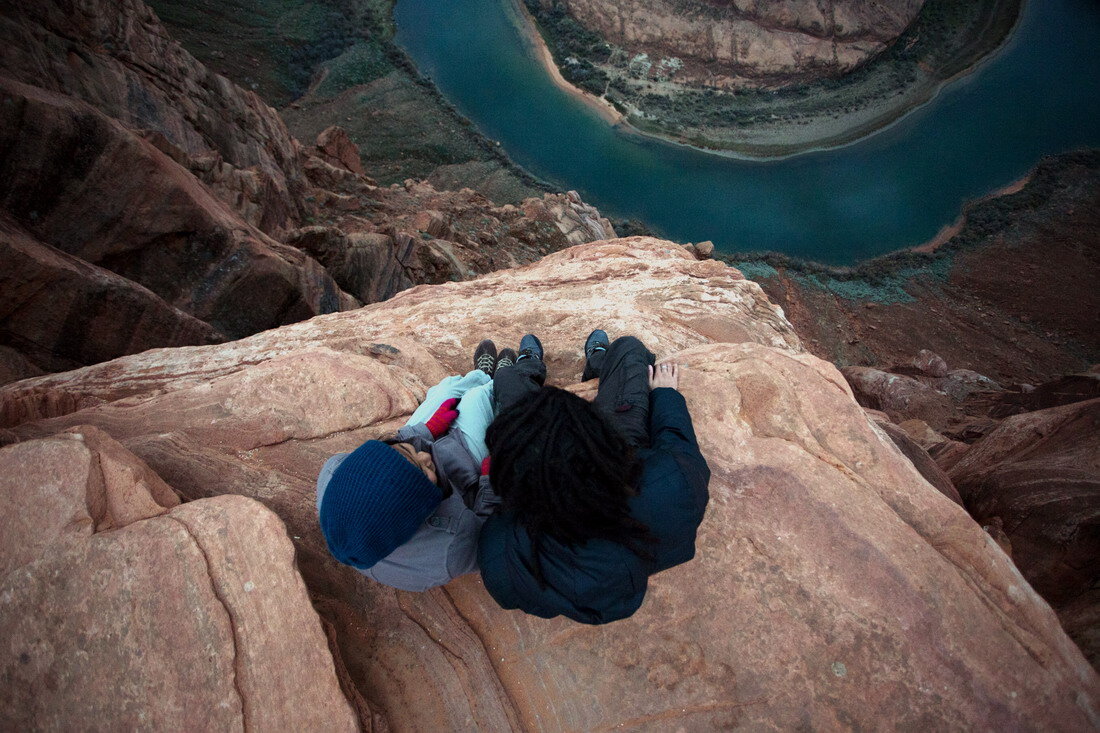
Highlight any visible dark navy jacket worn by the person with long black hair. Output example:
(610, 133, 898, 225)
(477, 389, 711, 624)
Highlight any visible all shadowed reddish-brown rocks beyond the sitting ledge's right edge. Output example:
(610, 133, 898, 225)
(840, 343, 1100, 665)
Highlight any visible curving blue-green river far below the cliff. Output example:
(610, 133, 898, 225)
(395, 0, 1100, 264)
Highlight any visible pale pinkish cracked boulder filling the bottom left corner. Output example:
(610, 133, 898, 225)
(0, 426, 356, 731)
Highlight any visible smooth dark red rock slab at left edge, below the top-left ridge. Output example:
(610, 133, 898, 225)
(0, 79, 356, 338)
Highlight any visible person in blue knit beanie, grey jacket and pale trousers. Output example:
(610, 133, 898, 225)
(317, 339, 517, 591)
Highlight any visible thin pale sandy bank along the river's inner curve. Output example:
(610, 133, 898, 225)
(512, 0, 1023, 159)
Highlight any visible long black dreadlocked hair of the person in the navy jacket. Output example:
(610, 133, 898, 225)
(485, 386, 653, 584)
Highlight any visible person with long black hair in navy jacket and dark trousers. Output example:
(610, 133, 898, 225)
(477, 330, 711, 624)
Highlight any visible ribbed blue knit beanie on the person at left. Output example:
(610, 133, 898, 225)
(321, 440, 442, 569)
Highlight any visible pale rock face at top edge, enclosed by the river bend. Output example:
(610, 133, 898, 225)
(561, 0, 924, 85)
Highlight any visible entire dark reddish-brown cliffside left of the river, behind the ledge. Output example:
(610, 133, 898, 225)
(0, 0, 614, 382)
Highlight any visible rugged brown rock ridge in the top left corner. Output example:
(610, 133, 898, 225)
(0, 0, 307, 232)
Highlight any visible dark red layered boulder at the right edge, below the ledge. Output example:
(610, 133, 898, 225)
(949, 400, 1100, 664)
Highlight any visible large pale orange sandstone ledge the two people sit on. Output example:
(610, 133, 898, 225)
(0, 238, 1100, 731)
